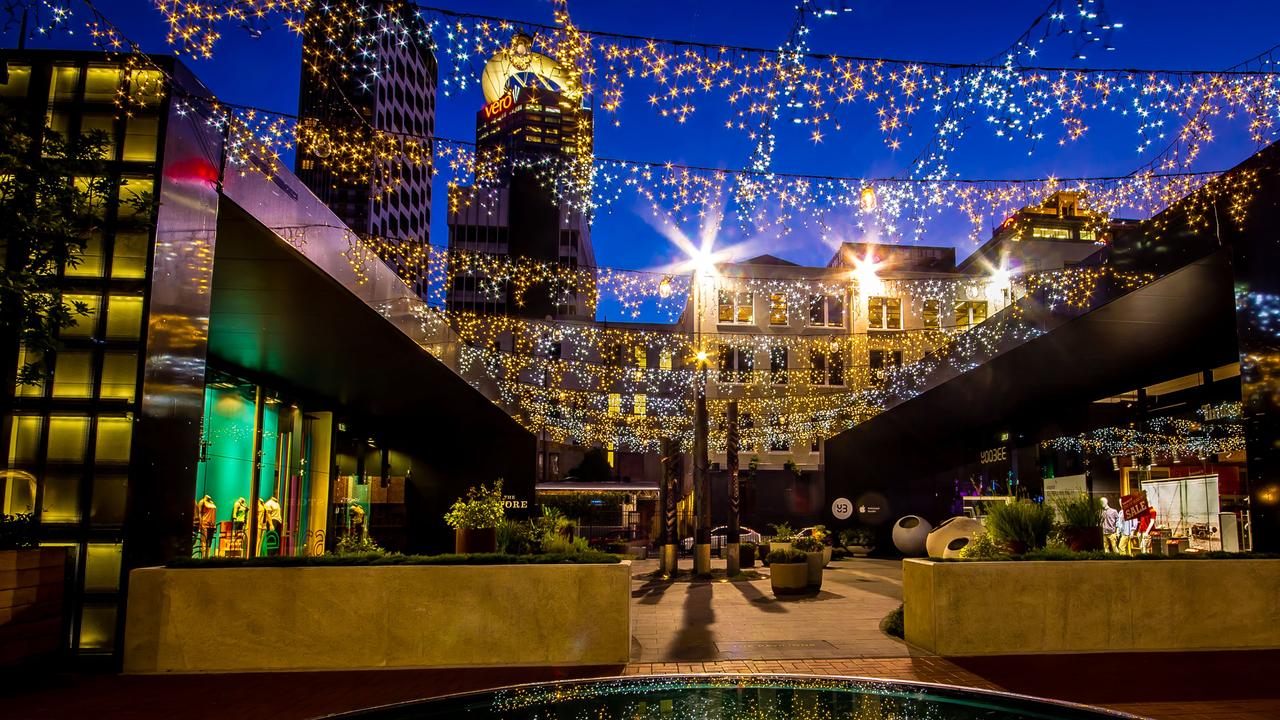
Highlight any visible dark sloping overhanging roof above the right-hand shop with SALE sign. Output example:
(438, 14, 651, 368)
(828, 250, 1239, 450)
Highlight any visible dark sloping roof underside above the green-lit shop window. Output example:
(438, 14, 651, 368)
(209, 197, 531, 439)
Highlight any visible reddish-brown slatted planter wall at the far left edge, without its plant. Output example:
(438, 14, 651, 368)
(0, 547, 67, 666)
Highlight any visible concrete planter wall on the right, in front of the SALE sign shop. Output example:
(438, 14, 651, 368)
(902, 560, 1280, 656)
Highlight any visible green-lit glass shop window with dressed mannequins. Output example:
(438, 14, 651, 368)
(191, 372, 333, 557)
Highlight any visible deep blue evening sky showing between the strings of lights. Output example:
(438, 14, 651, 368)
(6, 0, 1280, 294)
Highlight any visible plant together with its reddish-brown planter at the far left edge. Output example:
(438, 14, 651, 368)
(0, 509, 67, 662)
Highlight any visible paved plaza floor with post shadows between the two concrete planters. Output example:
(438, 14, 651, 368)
(631, 550, 913, 664)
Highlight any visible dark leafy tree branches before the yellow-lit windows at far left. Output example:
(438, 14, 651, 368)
(0, 108, 113, 384)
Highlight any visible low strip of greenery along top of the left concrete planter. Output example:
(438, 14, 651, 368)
(168, 551, 618, 569)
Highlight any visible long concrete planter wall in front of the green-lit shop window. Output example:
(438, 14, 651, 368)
(124, 561, 631, 673)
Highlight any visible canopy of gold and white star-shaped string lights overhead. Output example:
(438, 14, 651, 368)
(30, 0, 1280, 455)
